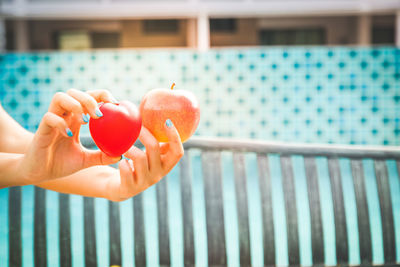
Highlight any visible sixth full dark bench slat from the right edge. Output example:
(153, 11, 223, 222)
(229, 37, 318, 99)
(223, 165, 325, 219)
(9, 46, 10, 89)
(257, 154, 275, 266)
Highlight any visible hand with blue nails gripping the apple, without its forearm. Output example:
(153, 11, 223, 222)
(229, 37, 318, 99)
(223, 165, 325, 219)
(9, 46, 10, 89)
(107, 121, 184, 201)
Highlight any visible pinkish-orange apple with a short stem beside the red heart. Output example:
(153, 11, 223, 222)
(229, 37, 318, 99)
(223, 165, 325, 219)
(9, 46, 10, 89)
(139, 84, 200, 142)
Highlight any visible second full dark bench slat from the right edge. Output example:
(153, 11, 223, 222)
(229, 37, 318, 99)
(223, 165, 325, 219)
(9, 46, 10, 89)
(351, 160, 372, 264)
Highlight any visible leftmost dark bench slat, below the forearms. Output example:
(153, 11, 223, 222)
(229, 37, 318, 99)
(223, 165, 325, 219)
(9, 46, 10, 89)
(8, 187, 22, 266)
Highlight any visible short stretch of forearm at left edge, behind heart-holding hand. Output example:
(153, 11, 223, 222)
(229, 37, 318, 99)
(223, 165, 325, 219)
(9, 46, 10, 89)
(0, 153, 29, 188)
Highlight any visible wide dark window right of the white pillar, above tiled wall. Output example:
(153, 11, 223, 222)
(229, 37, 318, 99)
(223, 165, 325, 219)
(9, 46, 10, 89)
(259, 29, 326, 45)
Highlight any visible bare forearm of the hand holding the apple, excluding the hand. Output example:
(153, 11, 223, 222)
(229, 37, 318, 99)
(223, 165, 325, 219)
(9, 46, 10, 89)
(36, 166, 120, 200)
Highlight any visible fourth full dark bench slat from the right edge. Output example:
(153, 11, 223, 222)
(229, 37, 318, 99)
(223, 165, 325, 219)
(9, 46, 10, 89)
(304, 157, 325, 265)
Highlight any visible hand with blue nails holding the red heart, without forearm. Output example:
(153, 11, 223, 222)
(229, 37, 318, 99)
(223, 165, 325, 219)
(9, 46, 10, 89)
(20, 89, 120, 184)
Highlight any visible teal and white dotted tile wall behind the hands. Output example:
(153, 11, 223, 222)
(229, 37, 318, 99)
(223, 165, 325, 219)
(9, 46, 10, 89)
(0, 47, 400, 145)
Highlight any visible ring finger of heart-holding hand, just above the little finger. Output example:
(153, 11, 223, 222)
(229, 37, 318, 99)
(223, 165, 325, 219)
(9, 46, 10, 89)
(49, 92, 85, 123)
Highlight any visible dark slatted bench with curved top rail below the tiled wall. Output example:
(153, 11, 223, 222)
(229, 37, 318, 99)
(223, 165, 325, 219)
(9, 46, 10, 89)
(0, 137, 400, 267)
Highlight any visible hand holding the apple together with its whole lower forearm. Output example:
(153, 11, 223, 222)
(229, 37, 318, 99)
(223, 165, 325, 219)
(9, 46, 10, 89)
(32, 122, 183, 201)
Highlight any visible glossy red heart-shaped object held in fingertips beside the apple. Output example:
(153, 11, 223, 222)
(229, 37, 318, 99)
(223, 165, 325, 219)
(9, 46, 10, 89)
(89, 101, 142, 157)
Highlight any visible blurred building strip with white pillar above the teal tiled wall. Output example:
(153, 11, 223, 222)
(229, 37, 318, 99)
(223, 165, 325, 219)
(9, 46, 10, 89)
(0, 0, 400, 51)
